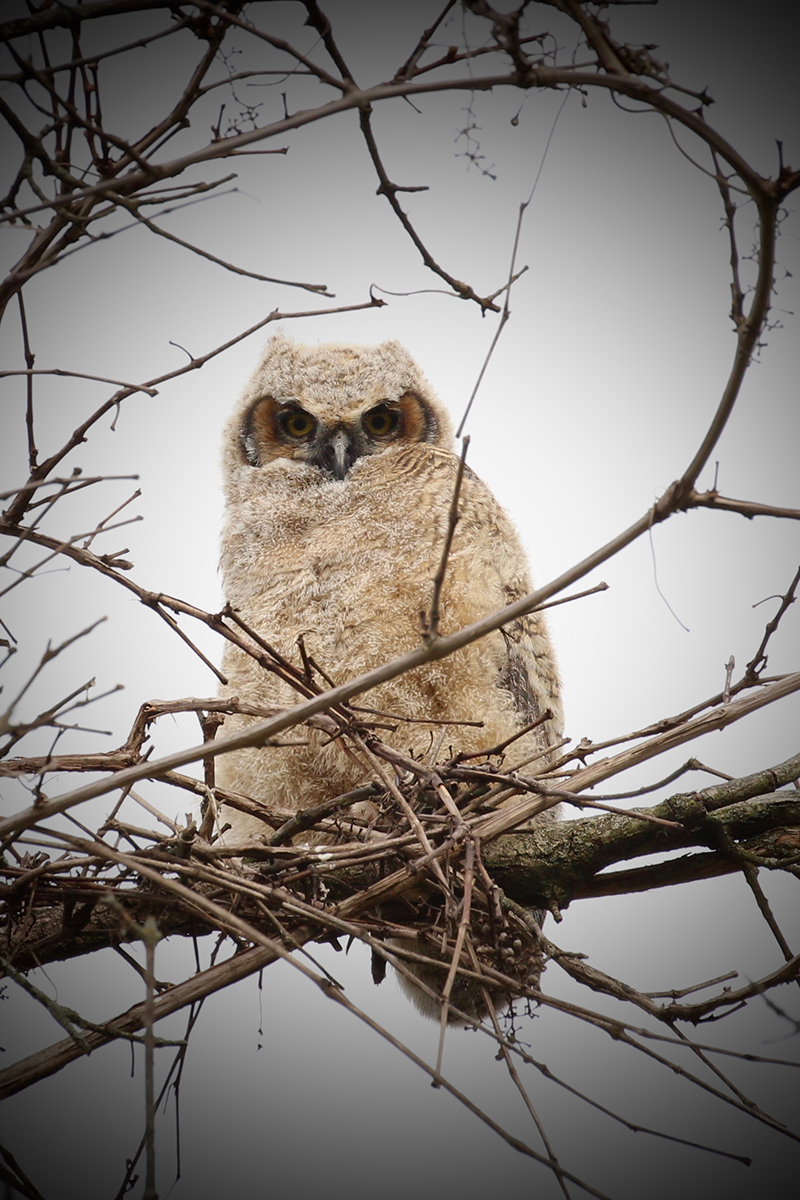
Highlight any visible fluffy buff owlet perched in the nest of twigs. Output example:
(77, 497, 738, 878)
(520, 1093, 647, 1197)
(217, 335, 561, 1012)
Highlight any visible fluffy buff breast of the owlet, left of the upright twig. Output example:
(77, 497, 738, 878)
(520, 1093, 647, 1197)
(222, 446, 474, 665)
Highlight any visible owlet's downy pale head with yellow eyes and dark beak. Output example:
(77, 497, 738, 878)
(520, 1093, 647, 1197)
(224, 334, 452, 480)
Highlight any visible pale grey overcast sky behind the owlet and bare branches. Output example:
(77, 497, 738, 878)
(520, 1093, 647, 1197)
(0, 7, 800, 1200)
